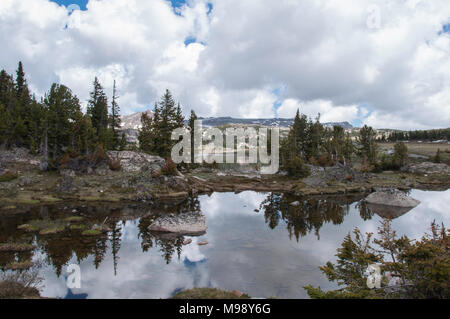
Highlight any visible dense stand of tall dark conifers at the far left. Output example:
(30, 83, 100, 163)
(0, 62, 126, 168)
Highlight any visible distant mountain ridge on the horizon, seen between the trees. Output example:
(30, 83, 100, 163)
(122, 111, 353, 130)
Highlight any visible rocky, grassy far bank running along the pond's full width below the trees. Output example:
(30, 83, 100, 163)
(0, 149, 450, 209)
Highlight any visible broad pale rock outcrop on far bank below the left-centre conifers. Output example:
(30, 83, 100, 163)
(108, 151, 165, 172)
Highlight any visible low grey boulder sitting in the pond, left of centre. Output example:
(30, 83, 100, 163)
(148, 212, 207, 235)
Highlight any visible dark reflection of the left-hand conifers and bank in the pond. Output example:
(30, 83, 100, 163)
(0, 197, 200, 277)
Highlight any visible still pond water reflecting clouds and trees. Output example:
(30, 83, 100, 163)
(0, 190, 450, 298)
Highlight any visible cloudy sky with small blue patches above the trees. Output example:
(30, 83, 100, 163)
(0, 0, 450, 129)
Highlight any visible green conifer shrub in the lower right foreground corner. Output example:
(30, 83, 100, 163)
(304, 220, 450, 299)
